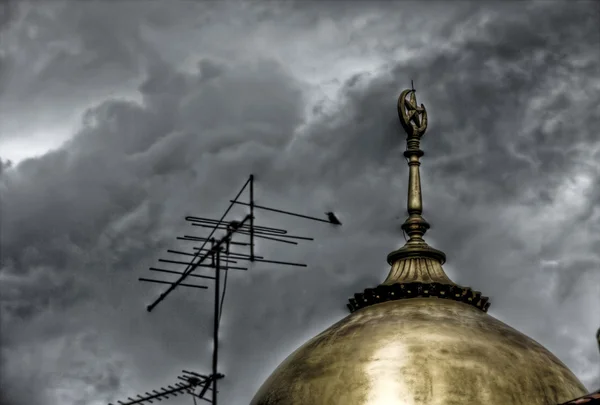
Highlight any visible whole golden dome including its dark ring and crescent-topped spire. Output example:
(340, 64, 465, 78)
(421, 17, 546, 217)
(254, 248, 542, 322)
(251, 89, 586, 405)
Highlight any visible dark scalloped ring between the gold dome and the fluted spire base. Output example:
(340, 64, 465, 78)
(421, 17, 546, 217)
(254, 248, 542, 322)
(347, 282, 490, 313)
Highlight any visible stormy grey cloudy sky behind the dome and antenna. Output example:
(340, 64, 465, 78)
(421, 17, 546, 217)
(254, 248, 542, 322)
(0, 0, 600, 405)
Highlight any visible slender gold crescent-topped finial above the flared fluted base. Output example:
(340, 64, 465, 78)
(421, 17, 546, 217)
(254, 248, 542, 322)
(388, 85, 446, 264)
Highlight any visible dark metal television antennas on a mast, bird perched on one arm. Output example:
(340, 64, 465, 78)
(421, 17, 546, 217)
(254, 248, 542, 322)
(109, 174, 341, 405)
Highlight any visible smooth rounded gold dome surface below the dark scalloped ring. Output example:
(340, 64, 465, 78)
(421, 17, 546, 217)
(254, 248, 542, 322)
(251, 298, 586, 405)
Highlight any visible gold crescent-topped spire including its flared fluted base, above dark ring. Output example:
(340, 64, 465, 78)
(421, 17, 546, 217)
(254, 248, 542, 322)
(384, 84, 454, 284)
